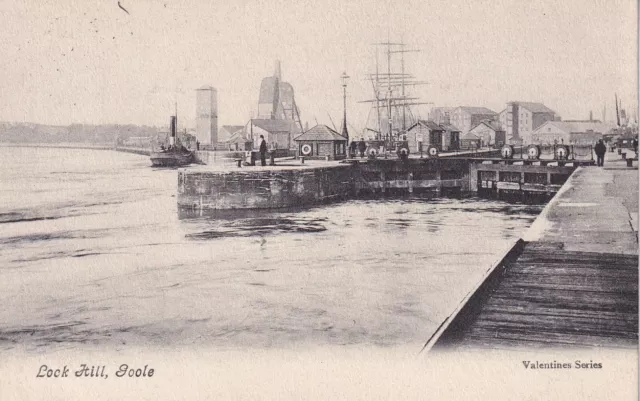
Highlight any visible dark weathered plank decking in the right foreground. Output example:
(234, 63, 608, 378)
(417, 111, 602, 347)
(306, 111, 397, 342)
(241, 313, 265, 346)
(428, 242, 638, 349)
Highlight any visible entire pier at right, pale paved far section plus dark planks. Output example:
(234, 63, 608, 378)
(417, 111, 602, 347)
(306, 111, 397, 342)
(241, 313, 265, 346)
(425, 153, 638, 350)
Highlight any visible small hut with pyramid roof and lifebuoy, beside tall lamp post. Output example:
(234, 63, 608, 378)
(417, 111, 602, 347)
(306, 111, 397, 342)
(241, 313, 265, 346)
(294, 125, 347, 160)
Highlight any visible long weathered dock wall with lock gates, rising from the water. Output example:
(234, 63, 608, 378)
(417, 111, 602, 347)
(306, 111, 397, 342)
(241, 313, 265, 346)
(178, 152, 588, 210)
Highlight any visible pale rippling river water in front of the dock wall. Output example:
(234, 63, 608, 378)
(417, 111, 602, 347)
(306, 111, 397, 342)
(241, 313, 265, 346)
(0, 148, 540, 350)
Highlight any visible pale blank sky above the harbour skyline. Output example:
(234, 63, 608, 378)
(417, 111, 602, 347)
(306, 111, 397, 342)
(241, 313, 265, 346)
(0, 0, 638, 130)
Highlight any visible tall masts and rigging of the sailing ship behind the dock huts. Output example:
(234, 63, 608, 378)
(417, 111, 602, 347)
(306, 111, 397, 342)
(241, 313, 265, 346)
(360, 40, 430, 148)
